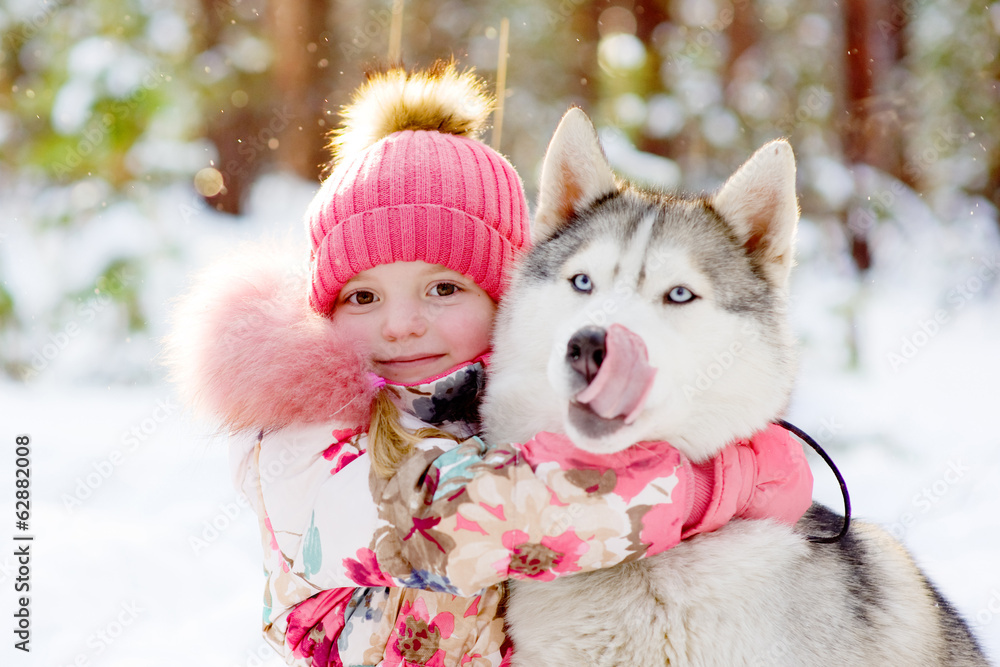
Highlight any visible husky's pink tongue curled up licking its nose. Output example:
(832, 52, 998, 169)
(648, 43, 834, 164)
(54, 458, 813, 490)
(576, 324, 656, 424)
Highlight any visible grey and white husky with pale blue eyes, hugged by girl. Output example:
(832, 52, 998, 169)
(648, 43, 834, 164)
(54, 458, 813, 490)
(483, 109, 987, 667)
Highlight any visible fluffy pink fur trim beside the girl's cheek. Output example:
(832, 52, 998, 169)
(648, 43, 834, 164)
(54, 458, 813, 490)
(166, 247, 374, 430)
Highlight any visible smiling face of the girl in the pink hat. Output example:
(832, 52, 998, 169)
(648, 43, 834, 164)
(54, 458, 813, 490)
(332, 261, 496, 384)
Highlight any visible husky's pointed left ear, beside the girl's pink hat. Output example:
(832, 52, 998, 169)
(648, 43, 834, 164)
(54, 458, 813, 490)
(531, 107, 618, 242)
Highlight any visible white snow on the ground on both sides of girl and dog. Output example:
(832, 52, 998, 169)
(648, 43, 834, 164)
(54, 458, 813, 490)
(0, 179, 1000, 667)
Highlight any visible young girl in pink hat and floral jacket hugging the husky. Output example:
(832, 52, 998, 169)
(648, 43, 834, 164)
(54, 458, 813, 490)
(172, 65, 811, 666)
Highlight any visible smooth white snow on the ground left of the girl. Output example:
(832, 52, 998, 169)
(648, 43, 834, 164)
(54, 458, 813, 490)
(0, 385, 280, 667)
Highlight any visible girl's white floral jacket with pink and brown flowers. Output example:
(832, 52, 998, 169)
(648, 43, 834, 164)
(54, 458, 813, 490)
(232, 363, 811, 667)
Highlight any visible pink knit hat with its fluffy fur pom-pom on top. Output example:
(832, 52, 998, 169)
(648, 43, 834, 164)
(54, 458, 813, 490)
(306, 65, 530, 314)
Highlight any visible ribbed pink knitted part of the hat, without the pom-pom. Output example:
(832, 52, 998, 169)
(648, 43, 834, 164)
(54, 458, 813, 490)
(306, 130, 530, 314)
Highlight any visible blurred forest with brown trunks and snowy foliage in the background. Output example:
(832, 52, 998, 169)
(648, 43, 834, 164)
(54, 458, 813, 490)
(0, 0, 1000, 383)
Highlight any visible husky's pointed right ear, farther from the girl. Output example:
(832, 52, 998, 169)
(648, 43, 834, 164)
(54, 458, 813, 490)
(711, 139, 799, 286)
